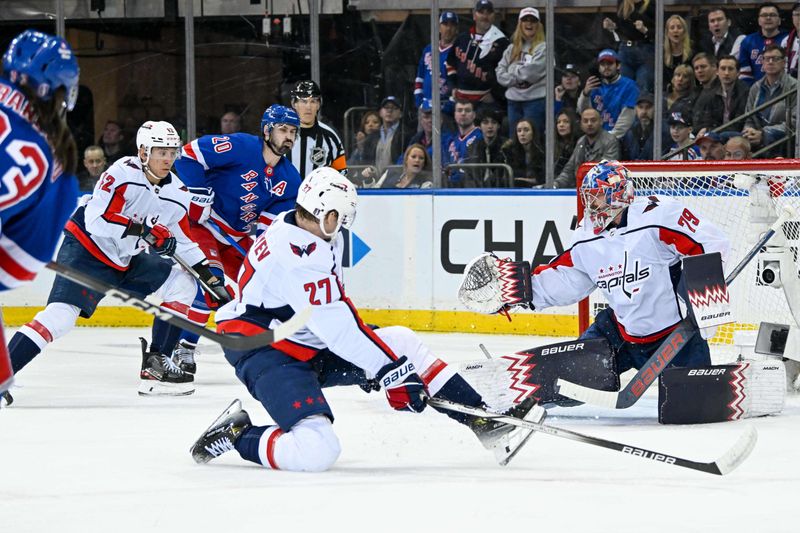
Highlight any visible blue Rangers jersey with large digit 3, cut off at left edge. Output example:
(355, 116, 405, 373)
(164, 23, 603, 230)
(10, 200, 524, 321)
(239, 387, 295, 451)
(0, 78, 78, 291)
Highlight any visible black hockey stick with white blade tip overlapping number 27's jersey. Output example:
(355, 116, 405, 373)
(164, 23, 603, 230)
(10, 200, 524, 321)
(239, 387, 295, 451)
(45, 261, 313, 351)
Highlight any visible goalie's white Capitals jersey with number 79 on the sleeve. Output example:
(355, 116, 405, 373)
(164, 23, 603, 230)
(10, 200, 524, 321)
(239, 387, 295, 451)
(532, 196, 730, 343)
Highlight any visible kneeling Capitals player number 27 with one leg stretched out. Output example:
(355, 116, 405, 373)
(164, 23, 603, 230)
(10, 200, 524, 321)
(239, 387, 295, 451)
(191, 167, 544, 471)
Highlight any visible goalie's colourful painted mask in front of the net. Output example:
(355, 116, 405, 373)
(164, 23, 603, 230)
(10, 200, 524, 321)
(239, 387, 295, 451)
(581, 159, 634, 235)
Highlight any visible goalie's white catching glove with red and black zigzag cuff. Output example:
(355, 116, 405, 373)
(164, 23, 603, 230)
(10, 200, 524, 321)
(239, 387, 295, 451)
(458, 253, 533, 315)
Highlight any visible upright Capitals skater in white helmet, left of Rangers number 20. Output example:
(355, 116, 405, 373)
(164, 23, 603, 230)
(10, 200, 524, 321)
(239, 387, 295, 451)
(9, 121, 224, 395)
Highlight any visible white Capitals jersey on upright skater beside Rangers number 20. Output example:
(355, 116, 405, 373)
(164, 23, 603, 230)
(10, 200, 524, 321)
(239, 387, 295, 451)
(66, 157, 205, 270)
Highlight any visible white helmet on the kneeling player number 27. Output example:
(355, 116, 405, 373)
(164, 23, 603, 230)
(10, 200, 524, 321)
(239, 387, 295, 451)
(297, 167, 358, 240)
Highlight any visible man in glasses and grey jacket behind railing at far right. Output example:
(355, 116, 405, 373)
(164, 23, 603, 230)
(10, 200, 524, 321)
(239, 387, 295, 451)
(742, 44, 797, 156)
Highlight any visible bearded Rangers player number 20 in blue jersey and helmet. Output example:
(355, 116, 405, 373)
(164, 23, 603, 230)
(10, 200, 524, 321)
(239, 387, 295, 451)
(174, 104, 302, 373)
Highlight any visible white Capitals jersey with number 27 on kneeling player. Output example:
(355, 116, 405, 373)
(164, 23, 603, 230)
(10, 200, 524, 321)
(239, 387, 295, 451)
(216, 211, 397, 376)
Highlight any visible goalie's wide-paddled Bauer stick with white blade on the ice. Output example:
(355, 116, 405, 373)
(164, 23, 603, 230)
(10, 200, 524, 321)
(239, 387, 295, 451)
(556, 205, 796, 409)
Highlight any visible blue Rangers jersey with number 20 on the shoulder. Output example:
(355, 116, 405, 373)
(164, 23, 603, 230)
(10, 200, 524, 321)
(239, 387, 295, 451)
(175, 133, 302, 236)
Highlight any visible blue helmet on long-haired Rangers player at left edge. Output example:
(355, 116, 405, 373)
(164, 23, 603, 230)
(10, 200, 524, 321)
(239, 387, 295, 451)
(3, 30, 80, 111)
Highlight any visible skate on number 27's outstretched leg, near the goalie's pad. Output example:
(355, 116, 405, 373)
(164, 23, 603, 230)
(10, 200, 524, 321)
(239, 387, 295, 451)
(469, 398, 547, 466)
